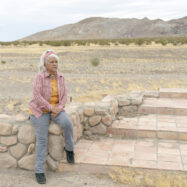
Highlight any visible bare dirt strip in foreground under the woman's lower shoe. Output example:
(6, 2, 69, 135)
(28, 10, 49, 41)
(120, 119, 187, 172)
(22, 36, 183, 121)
(0, 169, 129, 187)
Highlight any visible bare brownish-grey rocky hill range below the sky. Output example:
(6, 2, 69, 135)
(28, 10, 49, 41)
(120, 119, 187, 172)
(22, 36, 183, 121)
(21, 16, 187, 41)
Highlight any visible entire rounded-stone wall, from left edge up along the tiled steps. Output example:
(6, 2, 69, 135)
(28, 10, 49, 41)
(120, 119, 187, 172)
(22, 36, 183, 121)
(0, 92, 158, 171)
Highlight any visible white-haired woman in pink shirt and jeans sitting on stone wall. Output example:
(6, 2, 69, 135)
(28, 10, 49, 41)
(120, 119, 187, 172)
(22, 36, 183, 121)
(29, 50, 74, 184)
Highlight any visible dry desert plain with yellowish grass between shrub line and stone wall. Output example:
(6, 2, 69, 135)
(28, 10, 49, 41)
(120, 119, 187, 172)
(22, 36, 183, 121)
(0, 44, 187, 114)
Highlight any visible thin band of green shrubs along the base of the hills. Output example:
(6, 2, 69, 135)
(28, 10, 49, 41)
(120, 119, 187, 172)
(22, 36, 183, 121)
(0, 36, 187, 46)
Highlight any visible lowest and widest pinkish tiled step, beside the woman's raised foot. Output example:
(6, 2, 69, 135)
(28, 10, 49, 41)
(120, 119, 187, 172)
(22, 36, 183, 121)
(71, 138, 187, 171)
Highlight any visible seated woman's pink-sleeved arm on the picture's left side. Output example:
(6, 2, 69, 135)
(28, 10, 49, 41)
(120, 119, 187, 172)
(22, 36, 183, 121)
(33, 75, 53, 111)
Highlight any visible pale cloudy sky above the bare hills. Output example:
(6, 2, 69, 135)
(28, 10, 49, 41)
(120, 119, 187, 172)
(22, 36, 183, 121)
(0, 0, 187, 41)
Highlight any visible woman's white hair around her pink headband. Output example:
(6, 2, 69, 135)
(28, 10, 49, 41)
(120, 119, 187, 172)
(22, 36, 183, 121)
(39, 49, 59, 72)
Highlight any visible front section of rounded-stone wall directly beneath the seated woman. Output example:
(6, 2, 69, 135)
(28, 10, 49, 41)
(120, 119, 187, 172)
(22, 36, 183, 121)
(0, 104, 84, 171)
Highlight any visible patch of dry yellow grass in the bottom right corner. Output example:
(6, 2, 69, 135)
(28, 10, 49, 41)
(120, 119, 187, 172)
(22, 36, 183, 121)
(109, 168, 187, 187)
